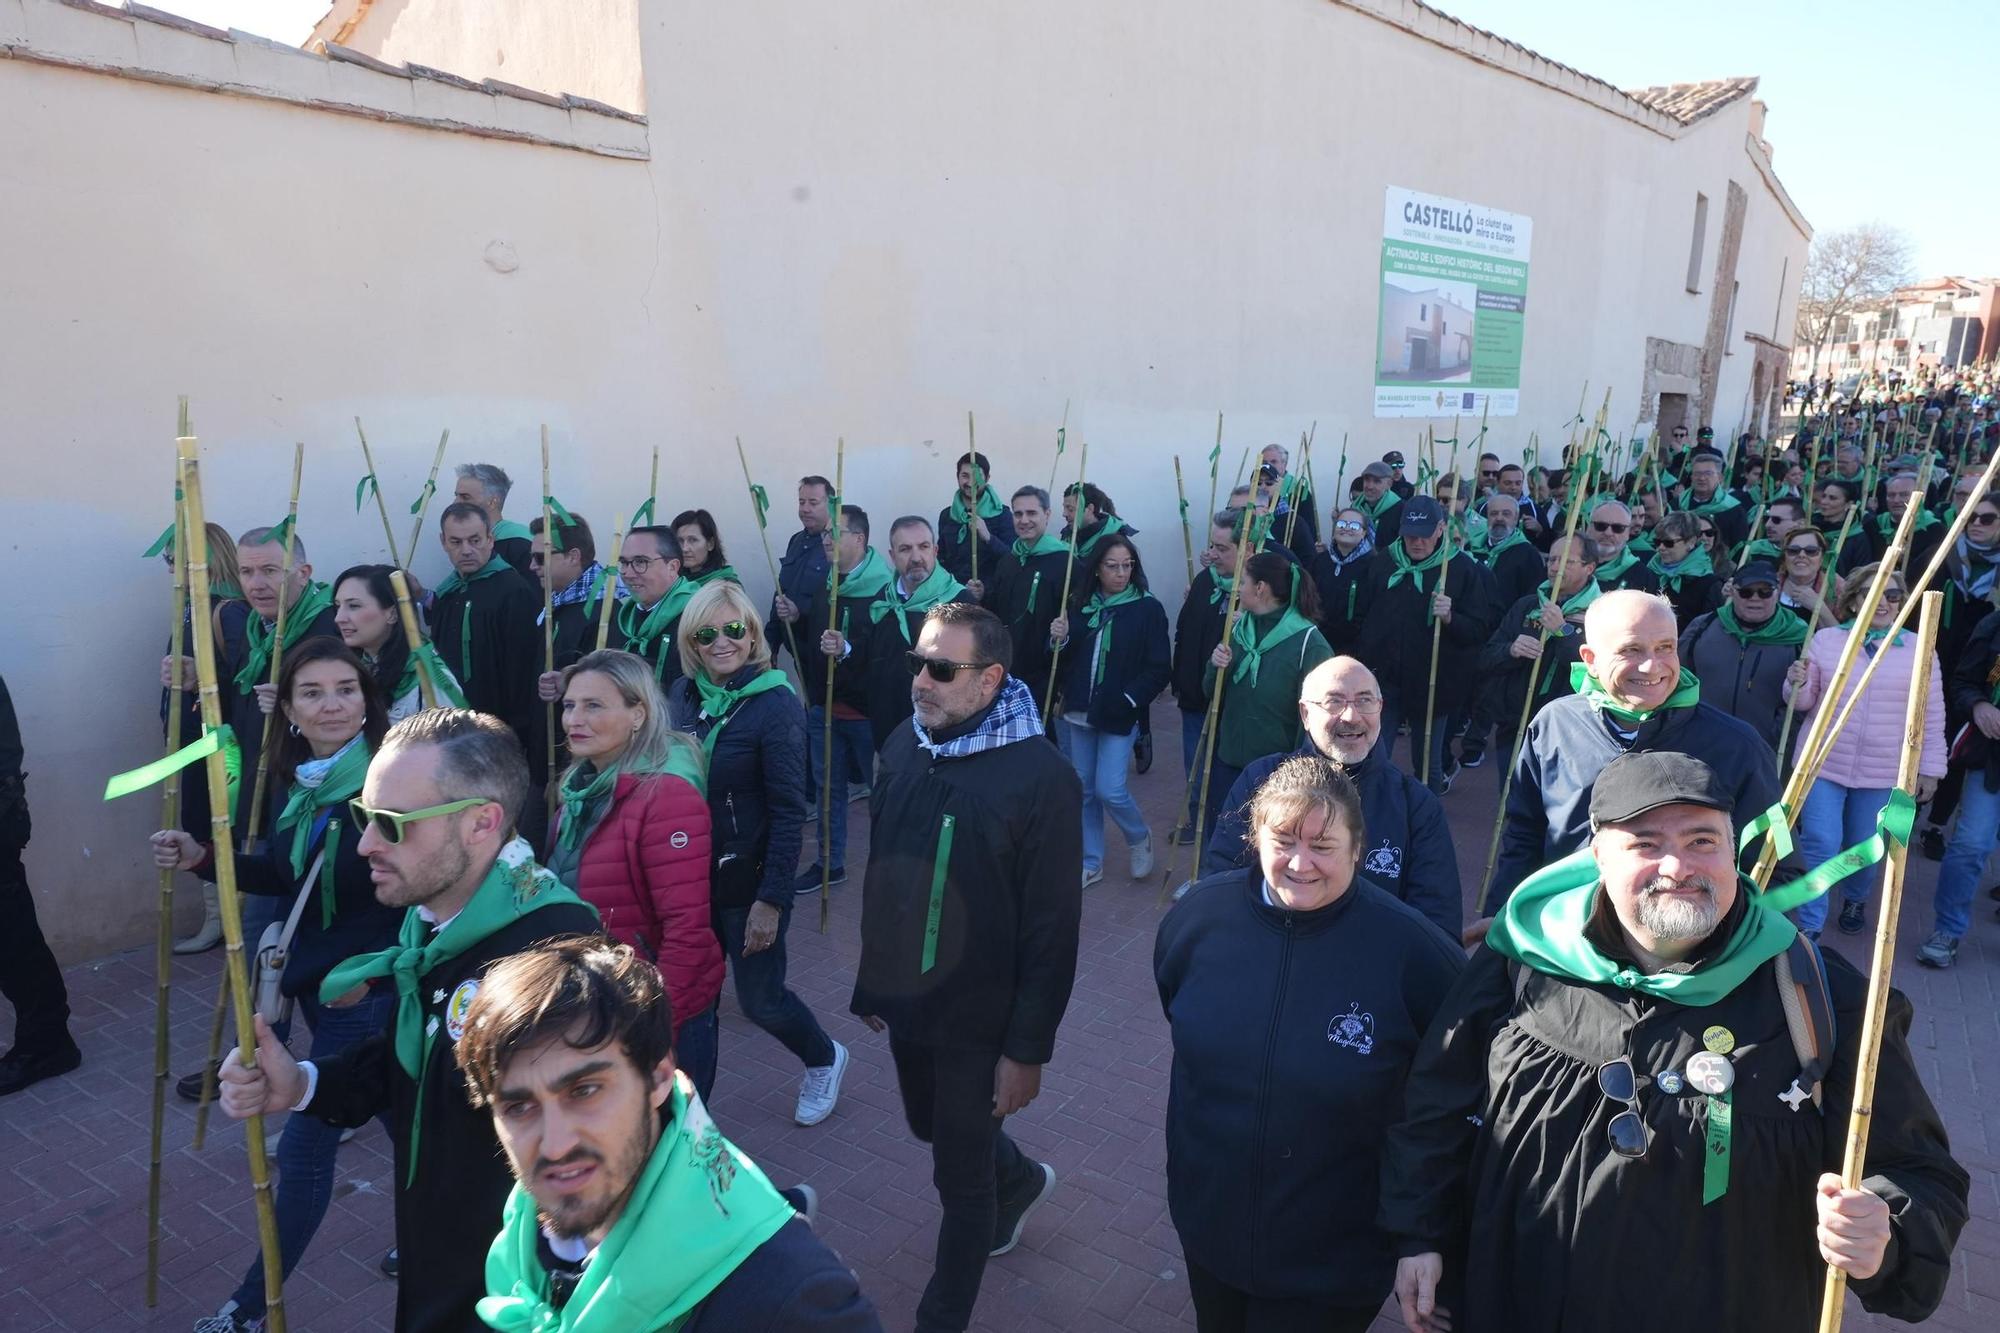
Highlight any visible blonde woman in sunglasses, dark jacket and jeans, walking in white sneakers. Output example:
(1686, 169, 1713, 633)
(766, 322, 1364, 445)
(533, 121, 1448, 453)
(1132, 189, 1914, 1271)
(668, 582, 848, 1125)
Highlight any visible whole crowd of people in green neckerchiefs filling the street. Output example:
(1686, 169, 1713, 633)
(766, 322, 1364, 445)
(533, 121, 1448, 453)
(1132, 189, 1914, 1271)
(0, 394, 2000, 1333)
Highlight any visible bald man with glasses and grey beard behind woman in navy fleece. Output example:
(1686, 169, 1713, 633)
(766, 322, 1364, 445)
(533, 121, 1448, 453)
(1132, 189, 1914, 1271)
(1202, 656, 1464, 939)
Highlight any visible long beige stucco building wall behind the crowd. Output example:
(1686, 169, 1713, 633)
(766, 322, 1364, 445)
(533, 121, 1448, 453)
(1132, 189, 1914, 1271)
(0, 0, 1804, 957)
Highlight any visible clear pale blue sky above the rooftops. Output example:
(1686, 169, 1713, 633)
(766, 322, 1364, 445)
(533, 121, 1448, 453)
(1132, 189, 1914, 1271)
(152, 0, 2000, 276)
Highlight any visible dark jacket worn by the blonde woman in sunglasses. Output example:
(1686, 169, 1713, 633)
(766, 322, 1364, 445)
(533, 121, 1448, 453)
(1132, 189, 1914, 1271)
(666, 667, 814, 909)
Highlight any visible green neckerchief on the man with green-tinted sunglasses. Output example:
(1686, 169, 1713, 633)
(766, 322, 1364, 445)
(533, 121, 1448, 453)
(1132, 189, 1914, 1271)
(320, 837, 596, 1189)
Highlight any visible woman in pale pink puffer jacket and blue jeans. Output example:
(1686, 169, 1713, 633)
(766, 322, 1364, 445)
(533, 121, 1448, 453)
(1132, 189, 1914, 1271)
(1786, 564, 1946, 939)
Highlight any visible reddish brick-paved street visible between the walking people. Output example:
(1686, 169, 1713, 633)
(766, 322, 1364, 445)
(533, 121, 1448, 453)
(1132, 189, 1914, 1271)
(0, 703, 2000, 1333)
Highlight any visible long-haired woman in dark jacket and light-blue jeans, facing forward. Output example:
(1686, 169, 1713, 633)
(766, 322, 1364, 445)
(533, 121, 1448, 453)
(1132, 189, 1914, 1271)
(1048, 532, 1172, 889)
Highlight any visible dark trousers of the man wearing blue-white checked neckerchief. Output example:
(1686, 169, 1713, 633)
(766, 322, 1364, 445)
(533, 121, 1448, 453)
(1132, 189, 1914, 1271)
(888, 1037, 1040, 1333)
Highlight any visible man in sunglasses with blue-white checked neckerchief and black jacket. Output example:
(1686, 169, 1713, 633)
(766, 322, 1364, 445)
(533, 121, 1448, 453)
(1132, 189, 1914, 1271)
(850, 602, 1084, 1333)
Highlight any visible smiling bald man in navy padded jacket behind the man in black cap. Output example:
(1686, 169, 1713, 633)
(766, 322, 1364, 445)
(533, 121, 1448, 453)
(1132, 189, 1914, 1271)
(1484, 590, 1798, 911)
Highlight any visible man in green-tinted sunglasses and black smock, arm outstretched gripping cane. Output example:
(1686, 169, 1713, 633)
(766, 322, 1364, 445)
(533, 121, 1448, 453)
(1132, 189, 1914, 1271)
(218, 709, 598, 1333)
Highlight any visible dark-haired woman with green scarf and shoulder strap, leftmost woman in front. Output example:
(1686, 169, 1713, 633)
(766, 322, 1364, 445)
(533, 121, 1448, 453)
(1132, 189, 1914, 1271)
(152, 638, 404, 1333)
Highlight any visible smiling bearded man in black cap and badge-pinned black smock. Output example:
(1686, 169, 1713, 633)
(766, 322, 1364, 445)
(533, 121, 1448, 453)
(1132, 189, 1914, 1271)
(1378, 753, 1970, 1333)
